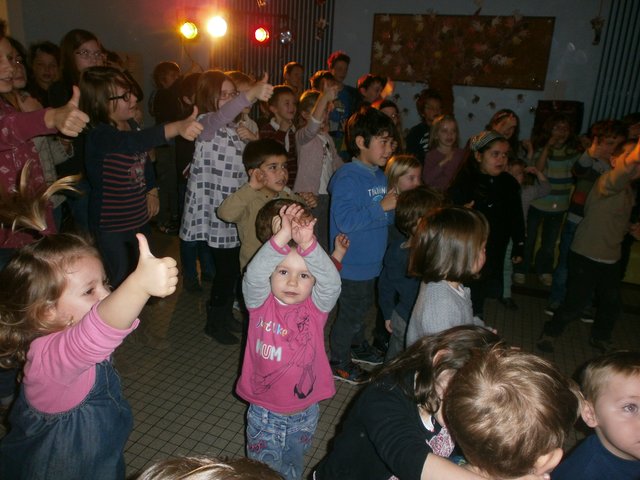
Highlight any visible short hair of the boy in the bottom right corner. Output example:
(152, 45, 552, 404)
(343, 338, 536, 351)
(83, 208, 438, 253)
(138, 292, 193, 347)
(579, 350, 640, 403)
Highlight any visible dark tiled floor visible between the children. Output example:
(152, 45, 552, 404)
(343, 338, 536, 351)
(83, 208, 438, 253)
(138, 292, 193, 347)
(0, 234, 640, 477)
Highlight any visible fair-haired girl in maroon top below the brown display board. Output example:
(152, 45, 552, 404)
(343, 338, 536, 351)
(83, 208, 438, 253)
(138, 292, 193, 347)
(422, 115, 464, 192)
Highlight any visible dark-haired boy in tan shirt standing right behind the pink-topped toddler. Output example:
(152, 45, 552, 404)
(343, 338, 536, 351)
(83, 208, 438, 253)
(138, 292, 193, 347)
(217, 138, 304, 271)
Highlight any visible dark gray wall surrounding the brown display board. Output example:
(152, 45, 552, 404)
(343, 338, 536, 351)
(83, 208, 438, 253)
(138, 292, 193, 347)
(333, 0, 610, 141)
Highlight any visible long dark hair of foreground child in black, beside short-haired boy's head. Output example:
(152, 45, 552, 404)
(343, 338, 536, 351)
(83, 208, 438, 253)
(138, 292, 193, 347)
(371, 325, 506, 413)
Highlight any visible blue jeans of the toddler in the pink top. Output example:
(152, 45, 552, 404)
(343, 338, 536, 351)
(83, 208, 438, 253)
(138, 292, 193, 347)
(247, 403, 320, 480)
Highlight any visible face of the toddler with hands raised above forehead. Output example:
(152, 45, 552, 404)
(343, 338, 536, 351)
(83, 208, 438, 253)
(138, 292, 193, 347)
(271, 250, 316, 305)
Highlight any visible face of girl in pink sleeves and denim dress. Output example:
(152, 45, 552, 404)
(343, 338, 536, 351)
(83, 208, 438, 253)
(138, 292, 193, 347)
(49, 256, 109, 328)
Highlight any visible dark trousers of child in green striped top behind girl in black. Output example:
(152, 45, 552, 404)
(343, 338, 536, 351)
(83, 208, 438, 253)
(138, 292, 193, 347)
(516, 207, 564, 275)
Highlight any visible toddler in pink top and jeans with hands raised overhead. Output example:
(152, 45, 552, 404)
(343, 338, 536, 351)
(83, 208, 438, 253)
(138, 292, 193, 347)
(236, 205, 340, 480)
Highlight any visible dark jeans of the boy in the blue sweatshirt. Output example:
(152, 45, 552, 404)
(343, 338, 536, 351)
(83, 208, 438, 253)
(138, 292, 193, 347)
(329, 278, 376, 367)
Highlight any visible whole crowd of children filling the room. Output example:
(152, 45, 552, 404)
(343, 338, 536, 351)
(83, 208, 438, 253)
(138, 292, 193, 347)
(0, 15, 640, 480)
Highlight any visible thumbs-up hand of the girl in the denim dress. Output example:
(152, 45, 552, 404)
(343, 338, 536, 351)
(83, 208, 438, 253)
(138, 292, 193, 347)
(132, 233, 178, 297)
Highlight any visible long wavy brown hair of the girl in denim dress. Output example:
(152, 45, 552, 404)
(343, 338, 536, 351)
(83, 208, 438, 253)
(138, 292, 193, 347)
(0, 234, 100, 368)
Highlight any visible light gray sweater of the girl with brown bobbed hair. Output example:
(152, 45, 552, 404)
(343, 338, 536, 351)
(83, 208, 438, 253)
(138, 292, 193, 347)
(407, 280, 484, 347)
